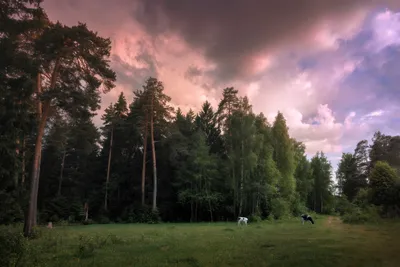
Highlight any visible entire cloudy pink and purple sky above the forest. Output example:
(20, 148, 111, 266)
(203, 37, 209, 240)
(43, 0, 400, 174)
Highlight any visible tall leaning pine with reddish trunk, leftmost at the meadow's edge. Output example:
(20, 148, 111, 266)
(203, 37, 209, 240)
(24, 20, 115, 236)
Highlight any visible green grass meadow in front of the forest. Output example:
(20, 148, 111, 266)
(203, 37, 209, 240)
(10, 217, 400, 267)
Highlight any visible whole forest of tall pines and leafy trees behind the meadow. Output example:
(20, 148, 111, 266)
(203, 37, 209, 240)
(0, 0, 400, 240)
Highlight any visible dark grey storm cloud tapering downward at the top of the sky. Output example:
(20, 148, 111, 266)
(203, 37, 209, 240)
(135, 0, 400, 80)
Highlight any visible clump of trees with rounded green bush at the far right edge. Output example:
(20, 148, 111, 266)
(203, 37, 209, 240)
(336, 131, 400, 222)
